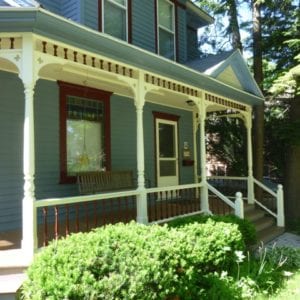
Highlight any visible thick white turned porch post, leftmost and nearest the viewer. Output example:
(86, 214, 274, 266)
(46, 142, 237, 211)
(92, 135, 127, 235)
(20, 34, 37, 259)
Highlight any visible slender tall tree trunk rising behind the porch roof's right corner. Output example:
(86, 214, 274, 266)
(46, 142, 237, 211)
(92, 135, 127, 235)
(252, 0, 264, 189)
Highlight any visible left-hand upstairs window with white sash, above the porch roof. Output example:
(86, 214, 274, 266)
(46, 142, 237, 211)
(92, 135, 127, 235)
(102, 0, 128, 41)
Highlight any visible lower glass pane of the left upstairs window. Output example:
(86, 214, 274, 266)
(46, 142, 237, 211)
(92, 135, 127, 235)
(104, 1, 127, 40)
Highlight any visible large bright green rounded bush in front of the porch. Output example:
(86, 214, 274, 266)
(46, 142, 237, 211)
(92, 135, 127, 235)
(22, 220, 244, 300)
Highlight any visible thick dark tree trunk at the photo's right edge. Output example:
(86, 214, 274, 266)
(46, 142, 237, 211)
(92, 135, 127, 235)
(284, 77, 300, 223)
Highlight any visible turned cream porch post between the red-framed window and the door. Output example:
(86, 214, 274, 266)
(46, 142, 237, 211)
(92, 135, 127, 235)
(135, 72, 148, 224)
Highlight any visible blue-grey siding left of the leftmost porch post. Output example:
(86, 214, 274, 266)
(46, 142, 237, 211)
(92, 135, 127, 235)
(0, 71, 24, 231)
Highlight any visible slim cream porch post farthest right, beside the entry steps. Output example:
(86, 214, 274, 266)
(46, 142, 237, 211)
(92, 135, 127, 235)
(245, 108, 254, 204)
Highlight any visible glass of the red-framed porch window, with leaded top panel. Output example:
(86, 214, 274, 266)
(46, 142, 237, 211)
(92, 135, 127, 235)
(66, 96, 104, 176)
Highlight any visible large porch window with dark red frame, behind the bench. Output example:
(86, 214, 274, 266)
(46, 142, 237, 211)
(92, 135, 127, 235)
(59, 82, 110, 183)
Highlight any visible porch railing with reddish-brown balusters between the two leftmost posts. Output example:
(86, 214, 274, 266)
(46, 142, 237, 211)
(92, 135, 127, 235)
(35, 190, 139, 246)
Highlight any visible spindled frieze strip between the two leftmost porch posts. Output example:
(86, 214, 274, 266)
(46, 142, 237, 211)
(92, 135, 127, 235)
(37, 41, 137, 79)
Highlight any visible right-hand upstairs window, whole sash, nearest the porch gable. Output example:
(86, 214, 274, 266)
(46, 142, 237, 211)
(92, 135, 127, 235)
(157, 0, 175, 60)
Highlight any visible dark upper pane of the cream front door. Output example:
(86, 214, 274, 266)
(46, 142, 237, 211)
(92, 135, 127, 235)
(159, 124, 175, 157)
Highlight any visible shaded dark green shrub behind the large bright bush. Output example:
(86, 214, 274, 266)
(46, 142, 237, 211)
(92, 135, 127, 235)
(168, 214, 257, 247)
